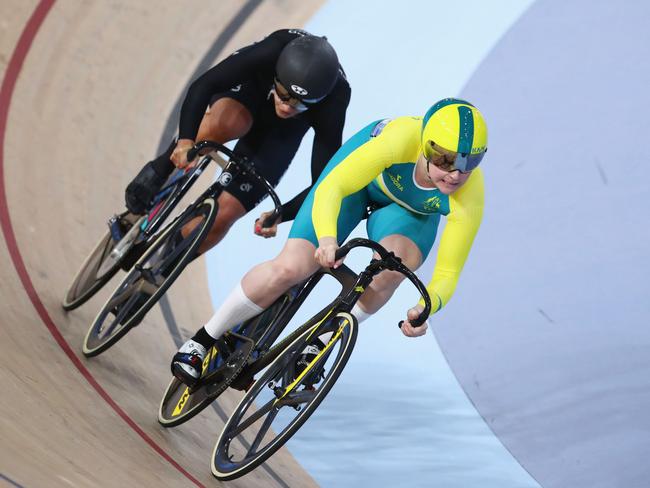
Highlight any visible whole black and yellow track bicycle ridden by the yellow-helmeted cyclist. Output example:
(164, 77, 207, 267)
(158, 234, 431, 480)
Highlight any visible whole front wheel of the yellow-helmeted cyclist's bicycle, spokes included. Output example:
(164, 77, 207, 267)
(211, 312, 358, 481)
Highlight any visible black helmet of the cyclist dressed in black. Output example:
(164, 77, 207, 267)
(275, 35, 339, 103)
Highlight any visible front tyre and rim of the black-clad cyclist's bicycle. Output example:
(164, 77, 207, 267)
(82, 198, 218, 357)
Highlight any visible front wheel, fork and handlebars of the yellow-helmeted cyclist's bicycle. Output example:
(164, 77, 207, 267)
(211, 238, 431, 481)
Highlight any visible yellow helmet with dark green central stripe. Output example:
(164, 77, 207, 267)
(421, 98, 487, 172)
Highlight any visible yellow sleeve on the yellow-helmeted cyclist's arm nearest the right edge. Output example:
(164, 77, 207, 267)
(420, 169, 484, 313)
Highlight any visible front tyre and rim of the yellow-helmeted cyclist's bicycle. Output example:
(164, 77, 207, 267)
(211, 312, 358, 481)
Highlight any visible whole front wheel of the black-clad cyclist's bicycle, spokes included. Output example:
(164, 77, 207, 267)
(83, 198, 218, 357)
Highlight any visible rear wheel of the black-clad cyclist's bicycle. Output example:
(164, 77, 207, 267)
(62, 212, 139, 310)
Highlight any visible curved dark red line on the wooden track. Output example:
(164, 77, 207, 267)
(0, 0, 205, 488)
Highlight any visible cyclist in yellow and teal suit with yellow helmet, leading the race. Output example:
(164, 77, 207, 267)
(172, 98, 487, 384)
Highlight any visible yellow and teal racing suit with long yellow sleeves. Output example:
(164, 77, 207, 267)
(290, 117, 484, 312)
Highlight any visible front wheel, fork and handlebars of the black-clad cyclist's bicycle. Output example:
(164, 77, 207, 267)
(83, 141, 281, 357)
